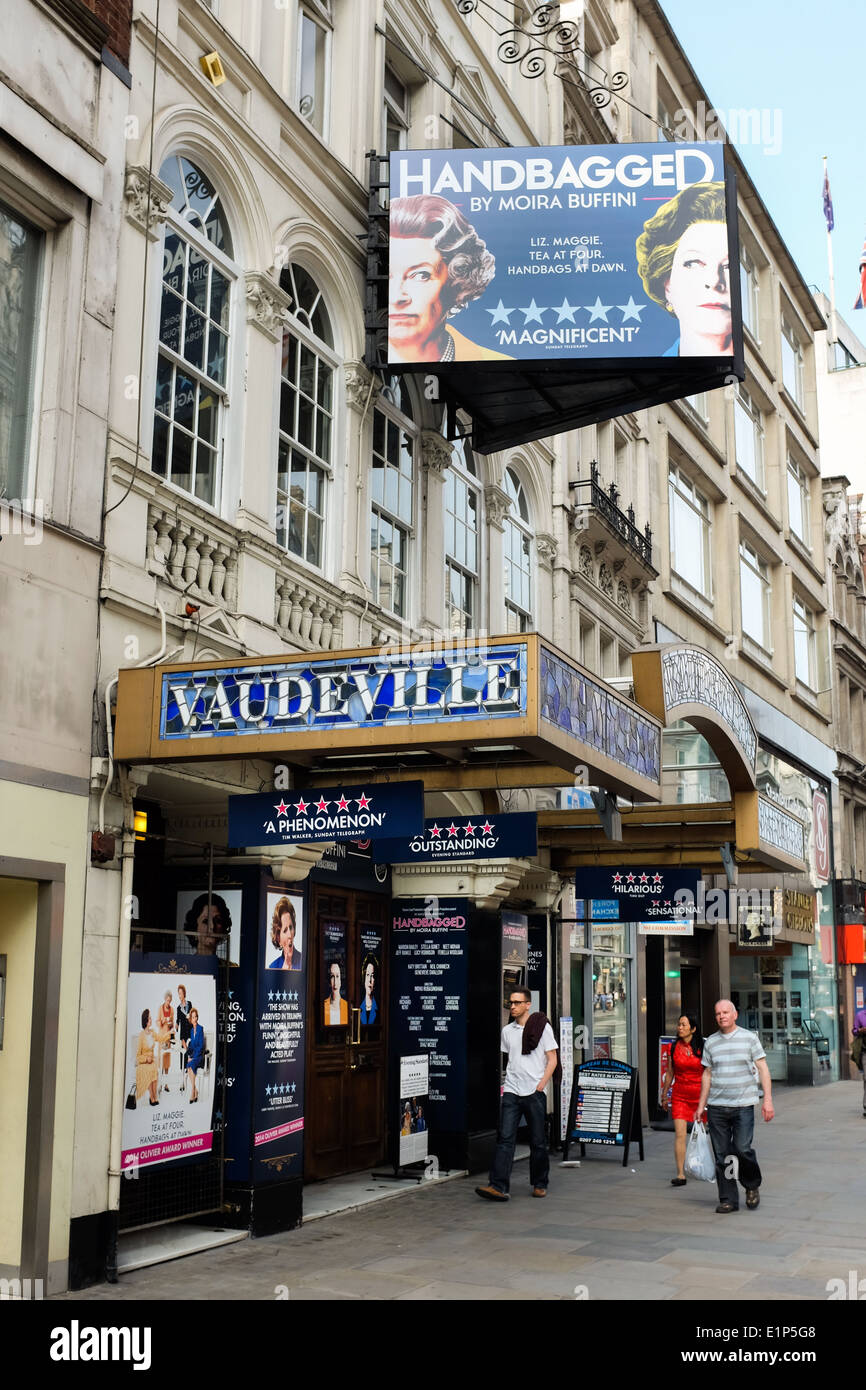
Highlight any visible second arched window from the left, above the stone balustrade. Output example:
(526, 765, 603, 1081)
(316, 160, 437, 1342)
(277, 264, 336, 569)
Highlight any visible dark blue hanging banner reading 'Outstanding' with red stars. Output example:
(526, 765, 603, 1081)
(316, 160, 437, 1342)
(373, 810, 538, 865)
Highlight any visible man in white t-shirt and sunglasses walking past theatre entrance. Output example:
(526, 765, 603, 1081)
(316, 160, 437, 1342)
(475, 990, 559, 1202)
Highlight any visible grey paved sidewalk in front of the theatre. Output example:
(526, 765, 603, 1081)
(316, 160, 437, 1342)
(58, 1081, 866, 1302)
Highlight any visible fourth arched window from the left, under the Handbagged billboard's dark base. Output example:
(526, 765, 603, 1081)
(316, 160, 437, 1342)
(445, 439, 481, 637)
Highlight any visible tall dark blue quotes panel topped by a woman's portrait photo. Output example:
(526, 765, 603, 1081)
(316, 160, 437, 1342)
(253, 884, 306, 1179)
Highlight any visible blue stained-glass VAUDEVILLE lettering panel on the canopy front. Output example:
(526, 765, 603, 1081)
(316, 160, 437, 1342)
(160, 648, 527, 739)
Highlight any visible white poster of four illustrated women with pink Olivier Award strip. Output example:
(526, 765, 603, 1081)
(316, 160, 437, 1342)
(121, 951, 217, 1170)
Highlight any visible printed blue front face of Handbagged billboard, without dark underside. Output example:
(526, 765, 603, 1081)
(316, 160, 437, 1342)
(388, 143, 741, 364)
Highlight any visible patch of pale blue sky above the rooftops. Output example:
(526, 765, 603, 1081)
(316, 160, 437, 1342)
(662, 0, 866, 322)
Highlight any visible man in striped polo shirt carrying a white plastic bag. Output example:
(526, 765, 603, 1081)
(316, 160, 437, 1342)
(695, 999, 776, 1215)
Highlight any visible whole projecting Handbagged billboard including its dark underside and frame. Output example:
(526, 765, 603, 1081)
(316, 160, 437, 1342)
(378, 142, 745, 453)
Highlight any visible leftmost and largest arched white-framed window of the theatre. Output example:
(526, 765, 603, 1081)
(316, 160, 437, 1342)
(150, 154, 236, 507)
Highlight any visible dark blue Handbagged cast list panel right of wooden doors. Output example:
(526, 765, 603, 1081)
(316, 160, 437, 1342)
(391, 898, 471, 1151)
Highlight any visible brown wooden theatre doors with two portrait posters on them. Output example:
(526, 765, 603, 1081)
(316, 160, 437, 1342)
(304, 884, 389, 1180)
